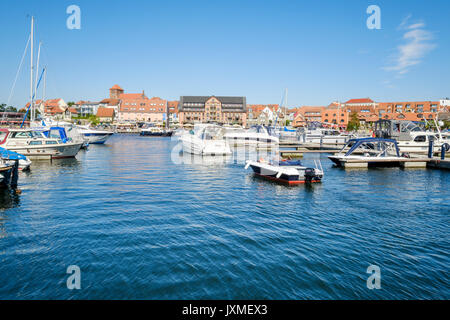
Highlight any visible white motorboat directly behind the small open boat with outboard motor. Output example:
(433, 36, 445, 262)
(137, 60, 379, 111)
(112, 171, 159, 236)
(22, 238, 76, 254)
(224, 126, 279, 147)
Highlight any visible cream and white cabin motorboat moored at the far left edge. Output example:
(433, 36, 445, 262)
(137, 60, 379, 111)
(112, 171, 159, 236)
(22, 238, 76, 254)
(0, 128, 83, 159)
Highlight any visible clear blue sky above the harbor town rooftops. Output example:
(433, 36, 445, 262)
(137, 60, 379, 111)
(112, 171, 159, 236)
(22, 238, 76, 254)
(0, 0, 450, 107)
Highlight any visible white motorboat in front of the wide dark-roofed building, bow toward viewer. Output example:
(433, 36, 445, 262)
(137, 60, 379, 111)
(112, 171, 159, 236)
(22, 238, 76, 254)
(180, 124, 232, 156)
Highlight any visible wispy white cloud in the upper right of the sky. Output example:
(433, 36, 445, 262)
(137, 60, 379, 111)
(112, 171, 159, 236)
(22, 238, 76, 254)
(384, 16, 436, 75)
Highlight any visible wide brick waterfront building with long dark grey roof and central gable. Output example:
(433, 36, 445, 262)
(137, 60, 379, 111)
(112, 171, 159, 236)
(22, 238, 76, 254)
(178, 96, 247, 126)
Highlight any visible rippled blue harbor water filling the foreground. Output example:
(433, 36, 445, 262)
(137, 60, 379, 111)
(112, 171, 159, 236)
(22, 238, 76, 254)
(0, 134, 450, 299)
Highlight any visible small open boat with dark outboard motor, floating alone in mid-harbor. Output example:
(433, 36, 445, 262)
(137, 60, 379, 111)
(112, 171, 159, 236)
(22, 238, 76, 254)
(245, 160, 323, 185)
